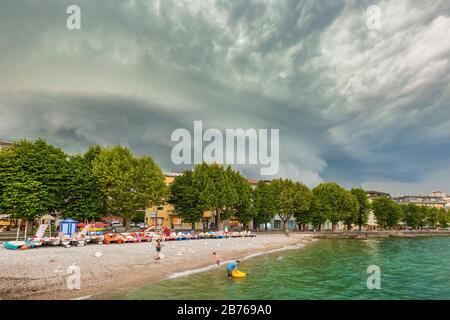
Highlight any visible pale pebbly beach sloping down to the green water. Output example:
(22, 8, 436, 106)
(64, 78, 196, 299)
(0, 234, 312, 299)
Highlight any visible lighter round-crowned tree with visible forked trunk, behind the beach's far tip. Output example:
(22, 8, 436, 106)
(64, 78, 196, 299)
(269, 179, 311, 233)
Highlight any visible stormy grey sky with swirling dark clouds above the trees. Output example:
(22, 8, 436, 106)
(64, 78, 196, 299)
(0, 0, 450, 195)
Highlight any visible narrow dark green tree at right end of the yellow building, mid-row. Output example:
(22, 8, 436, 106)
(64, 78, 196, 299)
(253, 181, 277, 231)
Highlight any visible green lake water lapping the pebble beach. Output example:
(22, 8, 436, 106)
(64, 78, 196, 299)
(120, 237, 450, 300)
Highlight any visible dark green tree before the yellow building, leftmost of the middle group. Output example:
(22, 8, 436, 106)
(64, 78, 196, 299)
(169, 170, 207, 230)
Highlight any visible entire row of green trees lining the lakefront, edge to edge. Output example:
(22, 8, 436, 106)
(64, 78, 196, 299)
(0, 140, 449, 231)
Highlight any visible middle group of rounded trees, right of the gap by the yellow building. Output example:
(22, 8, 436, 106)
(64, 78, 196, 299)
(169, 163, 370, 231)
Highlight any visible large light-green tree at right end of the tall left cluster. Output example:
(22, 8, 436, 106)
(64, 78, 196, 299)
(92, 146, 167, 231)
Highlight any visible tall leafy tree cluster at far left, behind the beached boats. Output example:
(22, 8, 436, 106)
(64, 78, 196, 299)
(0, 140, 166, 232)
